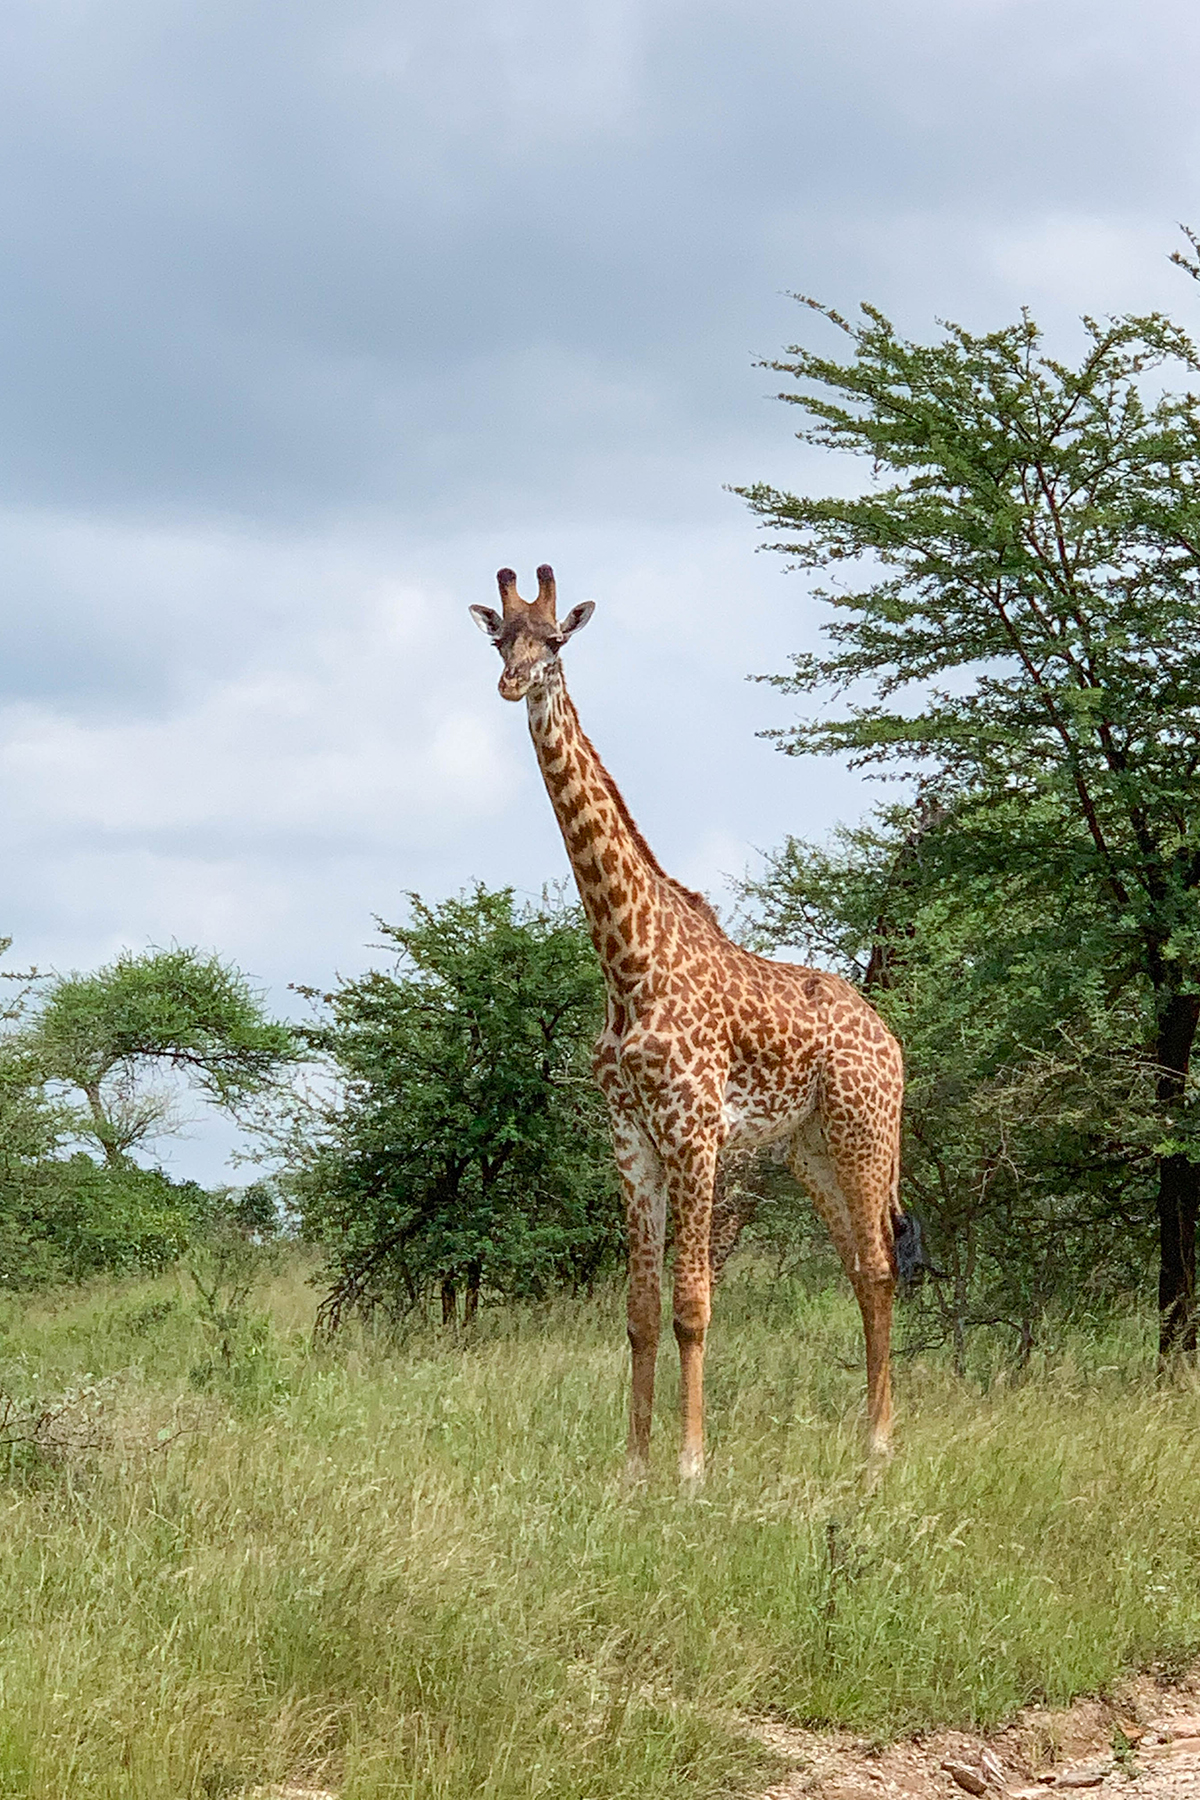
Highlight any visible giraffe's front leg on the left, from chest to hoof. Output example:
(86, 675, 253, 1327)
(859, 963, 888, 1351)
(612, 1105, 666, 1481)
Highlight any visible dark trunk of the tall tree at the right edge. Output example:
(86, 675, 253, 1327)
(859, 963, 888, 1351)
(1157, 994, 1200, 1357)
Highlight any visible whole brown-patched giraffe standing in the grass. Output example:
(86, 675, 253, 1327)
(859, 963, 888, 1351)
(470, 563, 903, 1485)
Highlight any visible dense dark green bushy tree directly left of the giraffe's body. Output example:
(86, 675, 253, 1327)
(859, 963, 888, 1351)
(295, 887, 621, 1323)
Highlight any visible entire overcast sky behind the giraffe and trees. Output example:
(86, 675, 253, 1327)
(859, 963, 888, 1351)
(0, 0, 1200, 1175)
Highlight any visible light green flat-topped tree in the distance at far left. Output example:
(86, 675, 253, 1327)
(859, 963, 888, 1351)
(25, 947, 297, 1163)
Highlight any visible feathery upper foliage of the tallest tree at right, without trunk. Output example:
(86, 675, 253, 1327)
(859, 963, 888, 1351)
(743, 308, 1200, 831)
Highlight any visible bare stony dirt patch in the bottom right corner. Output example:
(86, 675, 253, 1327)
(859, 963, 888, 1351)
(745, 1665, 1200, 1800)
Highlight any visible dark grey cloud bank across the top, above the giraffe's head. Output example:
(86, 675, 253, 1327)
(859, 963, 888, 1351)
(0, 0, 1196, 522)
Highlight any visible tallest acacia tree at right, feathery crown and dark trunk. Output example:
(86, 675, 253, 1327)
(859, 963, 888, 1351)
(739, 301, 1200, 1354)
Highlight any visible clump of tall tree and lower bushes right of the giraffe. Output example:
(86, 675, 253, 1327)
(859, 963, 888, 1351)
(743, 284, 1200, 1357)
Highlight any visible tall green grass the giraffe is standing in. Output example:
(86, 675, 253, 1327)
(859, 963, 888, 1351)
(0, 1267, 1200, 1800)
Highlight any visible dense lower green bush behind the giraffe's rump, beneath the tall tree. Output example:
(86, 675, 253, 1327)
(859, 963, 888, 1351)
(745, 808, 1159, 1366)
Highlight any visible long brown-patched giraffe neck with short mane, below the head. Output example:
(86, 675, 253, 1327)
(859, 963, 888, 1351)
(529, 664, 672, 997)
